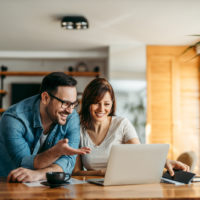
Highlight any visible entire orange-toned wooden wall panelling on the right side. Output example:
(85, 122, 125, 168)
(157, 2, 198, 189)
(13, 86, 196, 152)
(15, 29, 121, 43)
(147, 46, 200, 172)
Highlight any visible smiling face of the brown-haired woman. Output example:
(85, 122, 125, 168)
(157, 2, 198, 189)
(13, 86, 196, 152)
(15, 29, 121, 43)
(90, 92, 112, 122)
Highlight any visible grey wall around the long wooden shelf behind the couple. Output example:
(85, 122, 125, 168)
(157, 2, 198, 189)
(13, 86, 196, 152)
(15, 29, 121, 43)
(0, 50, 107, 109)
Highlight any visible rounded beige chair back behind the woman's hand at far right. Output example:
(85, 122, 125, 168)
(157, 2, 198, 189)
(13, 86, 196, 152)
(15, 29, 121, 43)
(177, 151, 197, 172)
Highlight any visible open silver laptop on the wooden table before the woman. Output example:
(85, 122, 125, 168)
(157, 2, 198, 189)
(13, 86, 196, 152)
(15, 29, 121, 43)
(87, 144, 169, 186)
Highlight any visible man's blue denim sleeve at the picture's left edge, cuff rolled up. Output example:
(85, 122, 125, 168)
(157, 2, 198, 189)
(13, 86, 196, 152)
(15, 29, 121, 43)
(1, 115, 35, 169)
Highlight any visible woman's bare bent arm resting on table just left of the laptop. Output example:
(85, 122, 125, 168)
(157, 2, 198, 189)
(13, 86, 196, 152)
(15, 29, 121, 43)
(72, 156, 106, 176)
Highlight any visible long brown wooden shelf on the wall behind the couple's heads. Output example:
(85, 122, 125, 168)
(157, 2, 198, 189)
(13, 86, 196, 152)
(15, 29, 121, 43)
(0, 71, 100, 77)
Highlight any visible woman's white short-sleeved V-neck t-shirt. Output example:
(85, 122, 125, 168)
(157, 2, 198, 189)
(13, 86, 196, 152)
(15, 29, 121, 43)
(80, 116, 138, 170)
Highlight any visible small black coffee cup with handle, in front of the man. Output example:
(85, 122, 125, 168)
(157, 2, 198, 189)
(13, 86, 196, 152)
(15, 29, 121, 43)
(46, 172, 71, 184)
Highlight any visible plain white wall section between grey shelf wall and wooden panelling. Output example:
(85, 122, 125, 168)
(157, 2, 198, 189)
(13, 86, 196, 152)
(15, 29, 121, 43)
(108, 44, 146, 80)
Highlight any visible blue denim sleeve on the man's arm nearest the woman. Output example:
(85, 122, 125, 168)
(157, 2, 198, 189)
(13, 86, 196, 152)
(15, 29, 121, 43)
(55, 112, 80, 174)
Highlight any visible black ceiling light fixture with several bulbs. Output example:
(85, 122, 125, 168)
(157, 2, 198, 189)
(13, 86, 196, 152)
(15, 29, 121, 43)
(61, 16, 89, 30)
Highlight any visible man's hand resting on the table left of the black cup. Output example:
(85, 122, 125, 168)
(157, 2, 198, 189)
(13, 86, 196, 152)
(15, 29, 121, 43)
(7, 167, 44, 183)
